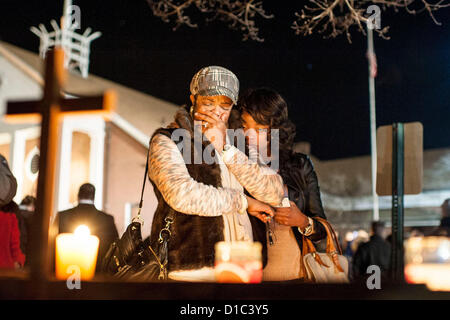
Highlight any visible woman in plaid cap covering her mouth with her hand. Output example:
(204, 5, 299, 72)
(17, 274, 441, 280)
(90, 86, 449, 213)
(149, 66, 283, 278)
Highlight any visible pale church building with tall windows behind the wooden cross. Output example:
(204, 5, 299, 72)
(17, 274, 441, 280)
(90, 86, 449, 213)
(0, 42, 178, 235)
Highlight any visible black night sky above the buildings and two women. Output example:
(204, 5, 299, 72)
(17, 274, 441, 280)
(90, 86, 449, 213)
(0, 0, 450, 160)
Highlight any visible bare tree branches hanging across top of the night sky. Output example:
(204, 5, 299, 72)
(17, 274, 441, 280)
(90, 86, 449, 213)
(147, 0, 450, 43)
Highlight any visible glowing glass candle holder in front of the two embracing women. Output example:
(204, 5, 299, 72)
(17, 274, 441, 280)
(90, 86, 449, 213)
(214, 241, 262, 283)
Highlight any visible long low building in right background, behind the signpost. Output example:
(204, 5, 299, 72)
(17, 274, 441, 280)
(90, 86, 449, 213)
(297, 142, 450, 231)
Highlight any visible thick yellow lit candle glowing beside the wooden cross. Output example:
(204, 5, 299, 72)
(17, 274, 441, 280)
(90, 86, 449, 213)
(55, 225, 100, 280)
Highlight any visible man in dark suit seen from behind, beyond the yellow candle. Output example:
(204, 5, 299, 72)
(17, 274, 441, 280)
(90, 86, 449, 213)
(55, 183, 118, 272)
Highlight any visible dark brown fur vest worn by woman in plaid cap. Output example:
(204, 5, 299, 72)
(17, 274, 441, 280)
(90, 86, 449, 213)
(150, 108, 224, 272)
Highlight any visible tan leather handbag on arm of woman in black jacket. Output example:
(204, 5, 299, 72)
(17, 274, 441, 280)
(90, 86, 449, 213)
(302, 217, 349, 283)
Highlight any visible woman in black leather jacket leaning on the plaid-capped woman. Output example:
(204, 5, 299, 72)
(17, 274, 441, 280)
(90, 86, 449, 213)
(238, 88, 326, 281)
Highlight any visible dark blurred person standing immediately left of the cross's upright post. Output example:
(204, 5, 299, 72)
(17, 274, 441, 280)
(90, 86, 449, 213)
(17, 196, 36, 265)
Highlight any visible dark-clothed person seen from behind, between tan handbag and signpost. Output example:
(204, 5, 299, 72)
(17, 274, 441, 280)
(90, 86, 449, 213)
(353, 221, 391, 278)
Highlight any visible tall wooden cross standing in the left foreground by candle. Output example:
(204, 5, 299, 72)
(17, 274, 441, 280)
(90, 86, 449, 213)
(6, 48, 116, 281)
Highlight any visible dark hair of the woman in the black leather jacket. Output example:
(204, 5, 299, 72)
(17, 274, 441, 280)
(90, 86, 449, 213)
(238, 88, 296, 167)
